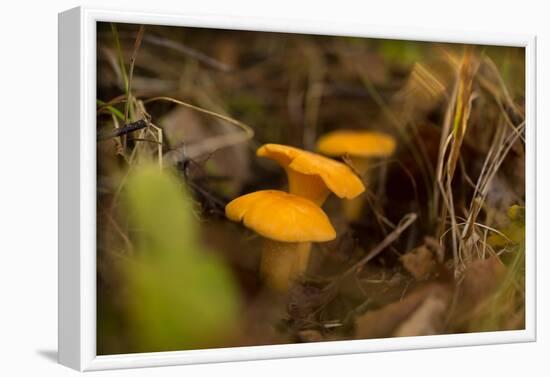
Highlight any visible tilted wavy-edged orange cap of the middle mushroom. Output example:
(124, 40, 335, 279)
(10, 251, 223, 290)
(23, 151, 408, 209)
(256, 144, 365, 199)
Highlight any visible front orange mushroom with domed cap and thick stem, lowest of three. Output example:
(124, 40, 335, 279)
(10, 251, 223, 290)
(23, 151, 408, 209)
(225, 190, 336, 292)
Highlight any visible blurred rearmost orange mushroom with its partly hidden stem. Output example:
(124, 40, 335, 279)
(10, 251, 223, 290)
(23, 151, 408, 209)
(317, 130, 396, 219)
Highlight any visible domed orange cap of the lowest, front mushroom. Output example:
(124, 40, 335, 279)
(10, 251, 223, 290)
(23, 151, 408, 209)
(225, 190, 336, 242)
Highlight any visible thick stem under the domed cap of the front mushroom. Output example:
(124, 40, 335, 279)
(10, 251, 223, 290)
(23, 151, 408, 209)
(260, 239, 311, 293)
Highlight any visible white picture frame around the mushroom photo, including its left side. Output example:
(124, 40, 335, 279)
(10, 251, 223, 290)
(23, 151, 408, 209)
(58, 7, 536, 371)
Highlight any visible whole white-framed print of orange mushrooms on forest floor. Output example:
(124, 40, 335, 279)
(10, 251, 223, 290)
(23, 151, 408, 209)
(59, 7, 536, 370)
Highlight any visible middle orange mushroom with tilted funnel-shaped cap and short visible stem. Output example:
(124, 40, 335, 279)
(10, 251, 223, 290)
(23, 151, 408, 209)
(256, 144, 365, 206)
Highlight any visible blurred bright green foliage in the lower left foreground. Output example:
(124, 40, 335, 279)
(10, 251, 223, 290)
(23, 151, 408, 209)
(125, 166, 239, 352)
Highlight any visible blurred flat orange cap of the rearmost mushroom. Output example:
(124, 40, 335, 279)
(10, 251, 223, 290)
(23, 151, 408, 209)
(317, 130, 395, 158)
